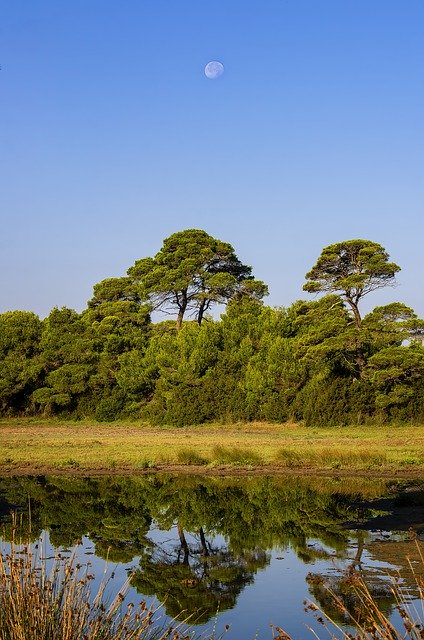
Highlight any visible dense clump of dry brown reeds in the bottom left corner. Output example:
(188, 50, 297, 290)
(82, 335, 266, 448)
(0, 532, 192, 640)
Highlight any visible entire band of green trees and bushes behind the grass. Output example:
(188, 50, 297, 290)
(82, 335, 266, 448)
(0, 229, 424, 426)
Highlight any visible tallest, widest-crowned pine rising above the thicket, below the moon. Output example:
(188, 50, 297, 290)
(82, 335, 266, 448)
(127, 229, 267, 330)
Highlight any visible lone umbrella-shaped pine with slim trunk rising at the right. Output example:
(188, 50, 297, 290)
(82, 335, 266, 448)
(303, 240, 400, 328)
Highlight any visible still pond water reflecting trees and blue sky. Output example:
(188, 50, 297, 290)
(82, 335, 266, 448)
(0, 475, 424, 640)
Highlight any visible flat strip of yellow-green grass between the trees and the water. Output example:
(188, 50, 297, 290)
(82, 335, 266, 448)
(0, 418, 424, 475)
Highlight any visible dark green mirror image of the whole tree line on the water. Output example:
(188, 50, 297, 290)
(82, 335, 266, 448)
(0, 475, 424, 623)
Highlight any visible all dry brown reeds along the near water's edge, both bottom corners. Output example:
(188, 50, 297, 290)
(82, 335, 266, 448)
(0, 542, 424, 640)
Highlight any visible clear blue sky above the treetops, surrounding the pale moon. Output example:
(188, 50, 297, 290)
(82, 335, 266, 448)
(0, 0, 424, 317)
